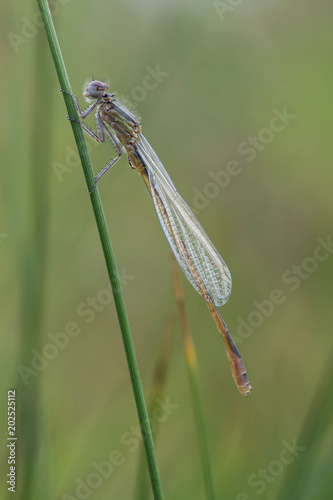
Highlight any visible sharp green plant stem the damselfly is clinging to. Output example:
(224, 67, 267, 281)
(38, 0, 163, 500)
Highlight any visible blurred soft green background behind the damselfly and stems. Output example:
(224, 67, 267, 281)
(0, 0, 333, 500)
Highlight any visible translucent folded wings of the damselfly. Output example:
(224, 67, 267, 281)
(138, 135, 232, 306)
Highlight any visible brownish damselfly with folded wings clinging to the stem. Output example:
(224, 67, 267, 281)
(61, 80, 252, 395)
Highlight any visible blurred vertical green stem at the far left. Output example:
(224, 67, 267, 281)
(15, 32, 53, 500)
